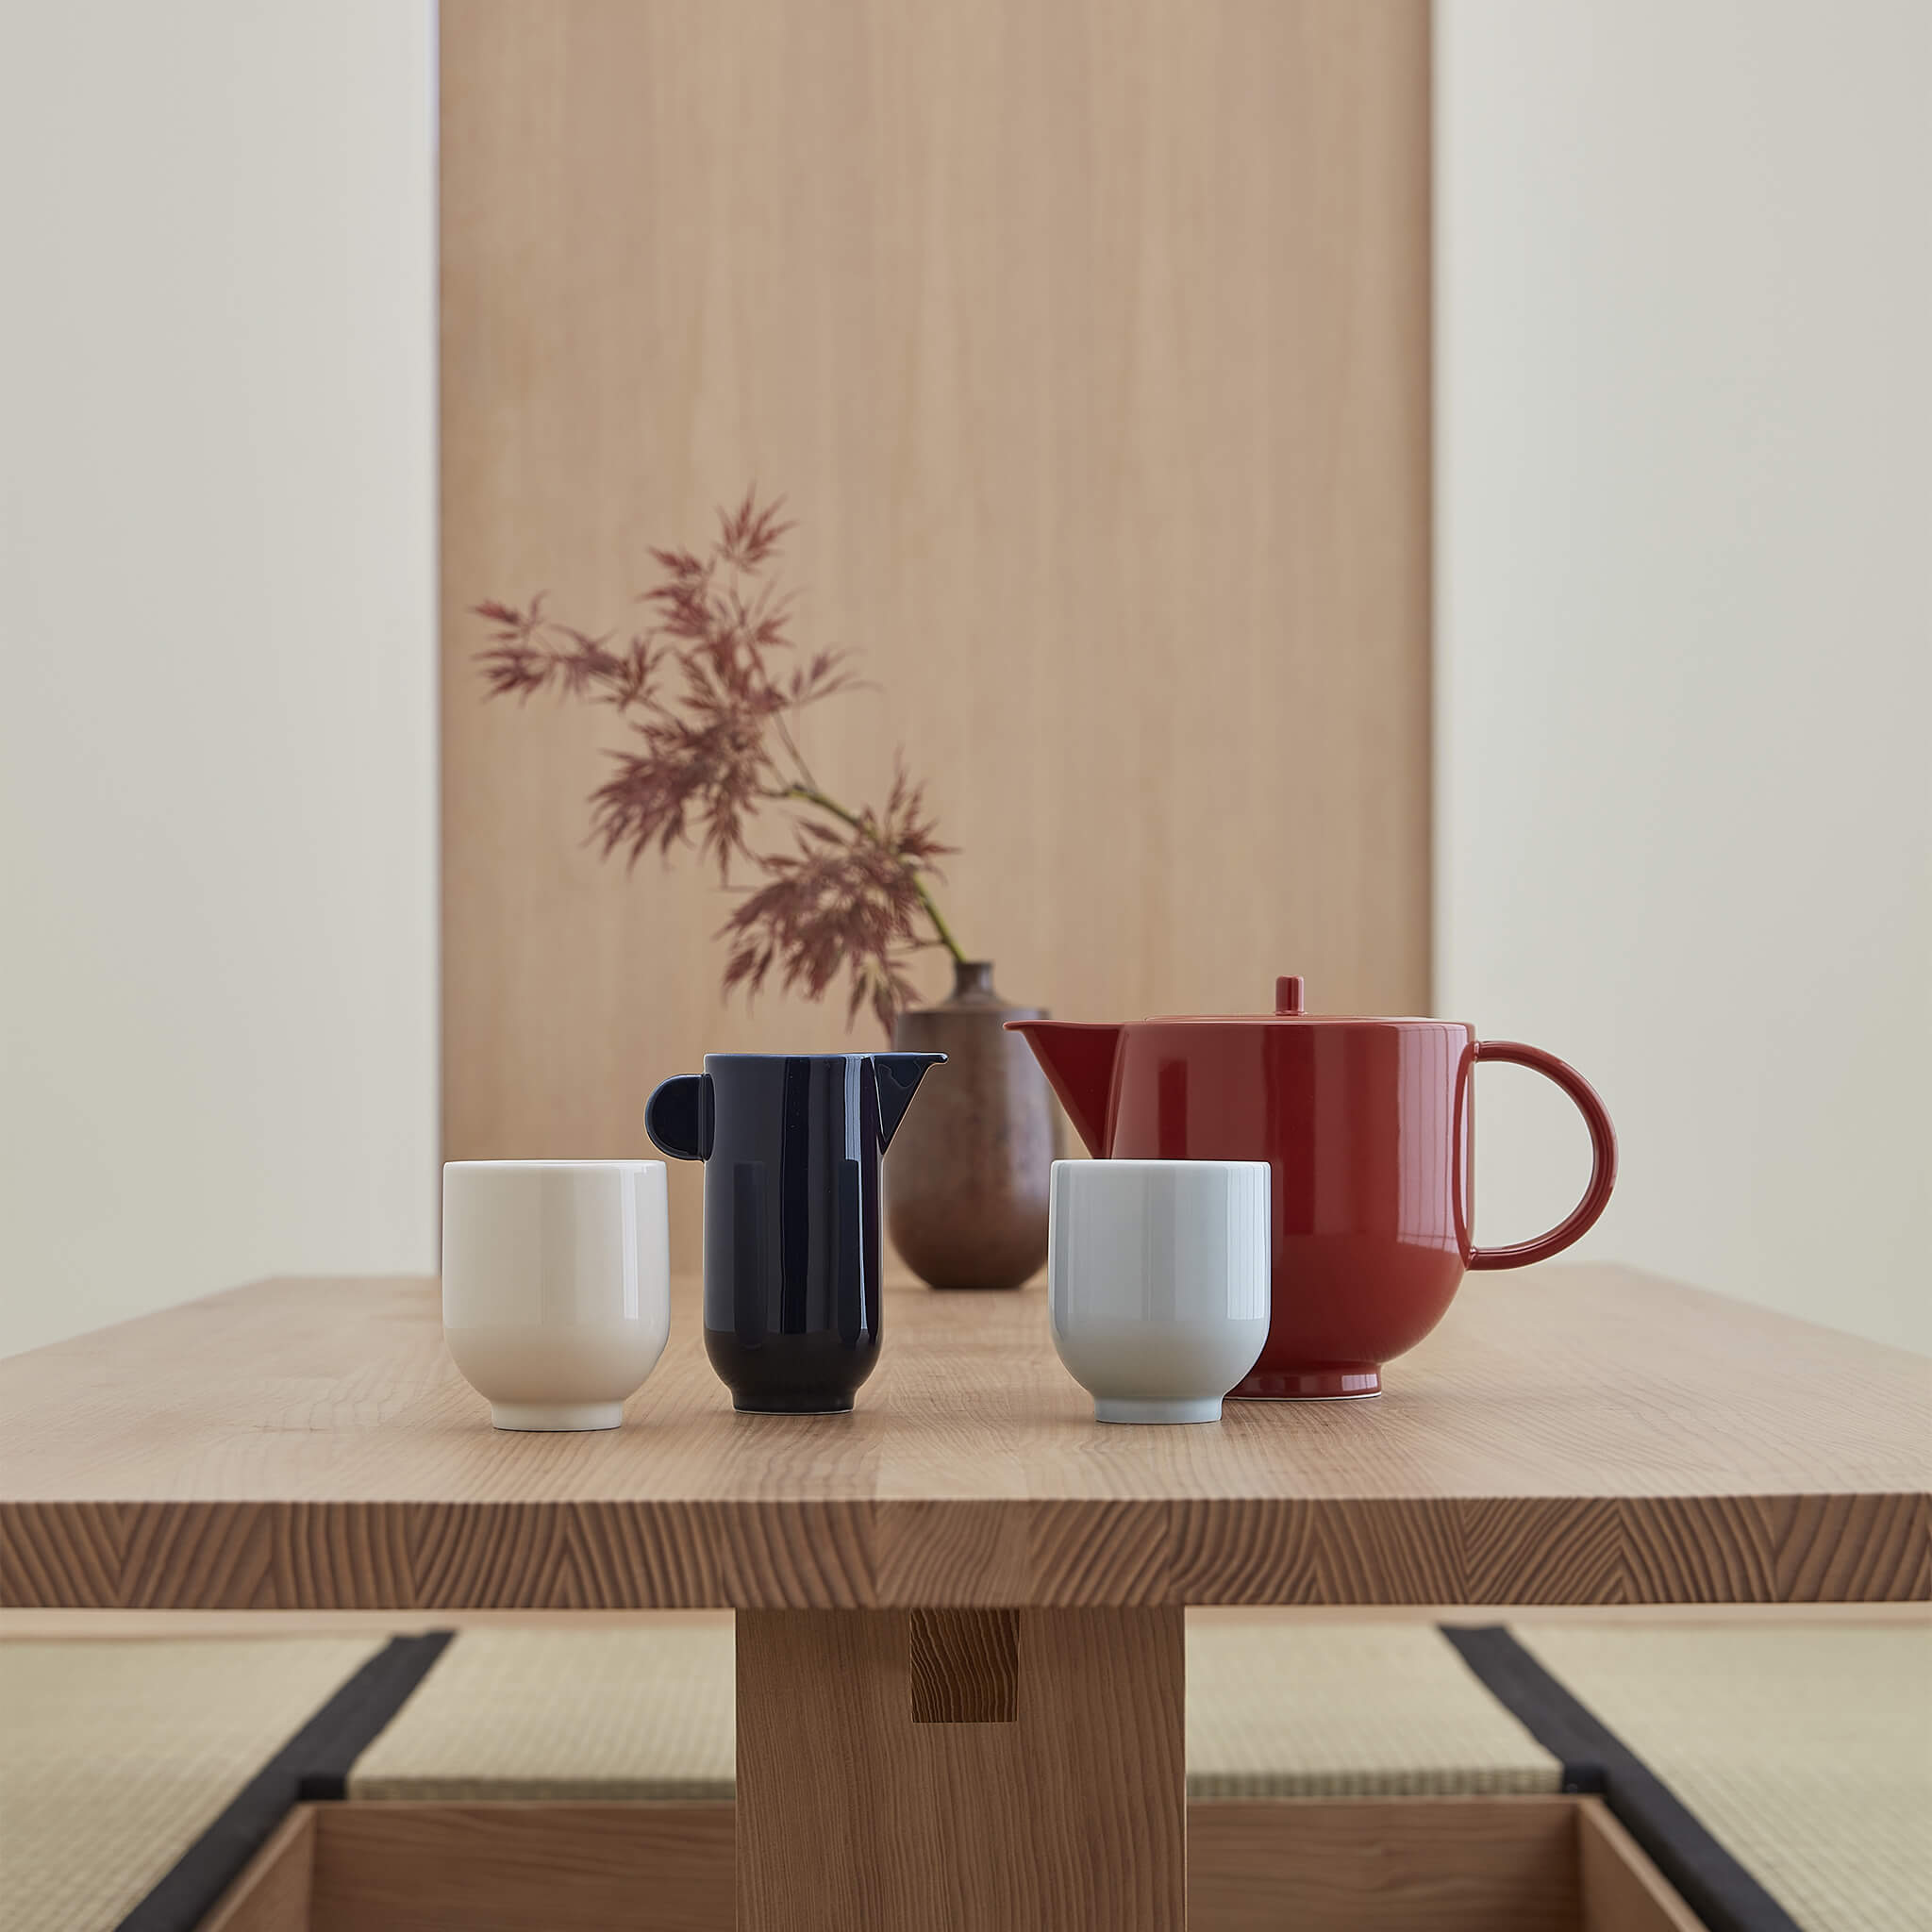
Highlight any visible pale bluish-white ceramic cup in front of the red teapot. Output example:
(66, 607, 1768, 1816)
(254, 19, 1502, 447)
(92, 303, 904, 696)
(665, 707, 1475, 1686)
(1047, 1161, 1270, 1422)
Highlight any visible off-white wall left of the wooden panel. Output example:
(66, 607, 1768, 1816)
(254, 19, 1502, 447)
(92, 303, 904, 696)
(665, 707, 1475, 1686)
(0, 0, 437, 1353)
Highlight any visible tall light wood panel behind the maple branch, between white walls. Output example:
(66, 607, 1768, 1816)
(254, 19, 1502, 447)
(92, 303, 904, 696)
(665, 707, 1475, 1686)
(442, 0, 1430, 1265)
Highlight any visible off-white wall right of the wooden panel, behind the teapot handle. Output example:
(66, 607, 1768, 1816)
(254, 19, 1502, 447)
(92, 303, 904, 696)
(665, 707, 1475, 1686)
(1438, 0, 1932, 1349)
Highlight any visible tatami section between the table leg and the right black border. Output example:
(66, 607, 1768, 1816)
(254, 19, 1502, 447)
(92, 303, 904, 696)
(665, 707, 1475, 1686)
(1189, 1619, 1563, 1799)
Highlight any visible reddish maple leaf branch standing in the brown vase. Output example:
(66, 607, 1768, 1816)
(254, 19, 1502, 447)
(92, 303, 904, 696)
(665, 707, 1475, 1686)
(475, 491, 964, 1032)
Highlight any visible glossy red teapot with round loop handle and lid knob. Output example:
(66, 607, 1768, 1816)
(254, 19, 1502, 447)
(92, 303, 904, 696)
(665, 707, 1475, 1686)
(1007, 977, 1617, 1397)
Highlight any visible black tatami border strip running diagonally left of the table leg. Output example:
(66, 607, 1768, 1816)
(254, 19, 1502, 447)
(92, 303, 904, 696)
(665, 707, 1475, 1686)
(118, 1631, 454, 1932)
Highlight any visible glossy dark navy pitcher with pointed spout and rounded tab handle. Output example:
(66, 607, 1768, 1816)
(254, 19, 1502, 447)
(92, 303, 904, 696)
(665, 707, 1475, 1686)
(643, 1053, 944, 1414)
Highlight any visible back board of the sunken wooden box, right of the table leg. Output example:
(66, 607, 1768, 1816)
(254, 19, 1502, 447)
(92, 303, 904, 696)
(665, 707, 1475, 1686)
(1189, 1797, 1578, 1932)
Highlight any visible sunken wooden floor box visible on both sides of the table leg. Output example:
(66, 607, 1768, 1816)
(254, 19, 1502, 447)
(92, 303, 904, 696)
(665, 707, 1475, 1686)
(201, 1797, 1698, 1932)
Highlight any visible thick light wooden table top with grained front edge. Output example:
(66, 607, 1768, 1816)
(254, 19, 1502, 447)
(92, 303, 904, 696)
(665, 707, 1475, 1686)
(0, 1265, 1932, 1611)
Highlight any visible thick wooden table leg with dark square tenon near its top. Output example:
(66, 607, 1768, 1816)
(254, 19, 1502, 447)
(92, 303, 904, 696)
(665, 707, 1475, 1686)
(738, 1607, 1186, 1932)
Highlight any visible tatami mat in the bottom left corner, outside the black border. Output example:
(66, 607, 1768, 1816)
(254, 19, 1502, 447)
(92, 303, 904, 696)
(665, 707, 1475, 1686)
(0, 1637, 383, 1932)
